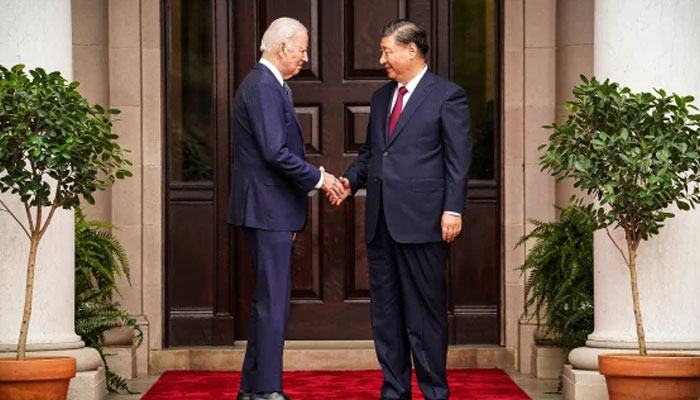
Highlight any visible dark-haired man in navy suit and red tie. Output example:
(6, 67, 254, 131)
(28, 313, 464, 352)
(329, 20, 471, 399)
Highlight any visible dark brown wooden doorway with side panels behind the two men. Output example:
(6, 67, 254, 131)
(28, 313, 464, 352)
(164, 0, 501, 346)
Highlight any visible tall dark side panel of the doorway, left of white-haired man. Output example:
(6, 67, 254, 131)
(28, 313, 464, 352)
(164, 0, 221, 345)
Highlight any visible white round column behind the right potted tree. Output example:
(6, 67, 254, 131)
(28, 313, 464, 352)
(564, 0, 700, 400)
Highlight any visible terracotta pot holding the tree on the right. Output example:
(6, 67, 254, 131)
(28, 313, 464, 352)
(598, 354, 700, 400)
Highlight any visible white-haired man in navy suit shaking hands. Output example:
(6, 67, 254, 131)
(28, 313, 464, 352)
(228, 18, 343, 400)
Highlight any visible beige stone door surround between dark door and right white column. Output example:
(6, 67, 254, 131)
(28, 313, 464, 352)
(504, 0, 556, 373)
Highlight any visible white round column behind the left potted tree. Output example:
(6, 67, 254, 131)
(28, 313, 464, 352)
(0, 0, 104, 399)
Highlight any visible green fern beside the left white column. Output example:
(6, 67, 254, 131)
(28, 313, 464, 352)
(75, 208, 143, 394)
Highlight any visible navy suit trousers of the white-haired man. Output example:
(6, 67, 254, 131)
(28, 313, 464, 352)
(240, 228, 292, 393)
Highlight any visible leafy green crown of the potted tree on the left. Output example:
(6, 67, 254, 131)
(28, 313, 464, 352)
(0, 65, 131, 208)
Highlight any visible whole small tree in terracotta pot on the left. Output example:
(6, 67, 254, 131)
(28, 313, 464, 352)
(0, 65, 131, 399)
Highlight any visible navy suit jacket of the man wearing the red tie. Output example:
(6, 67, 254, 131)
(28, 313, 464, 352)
(344, 71, 471, 243)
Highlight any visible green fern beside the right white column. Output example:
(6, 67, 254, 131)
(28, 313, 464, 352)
(518, 205, 596, 352)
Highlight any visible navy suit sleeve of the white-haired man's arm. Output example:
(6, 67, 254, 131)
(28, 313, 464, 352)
(249, 83, 321, 191)
